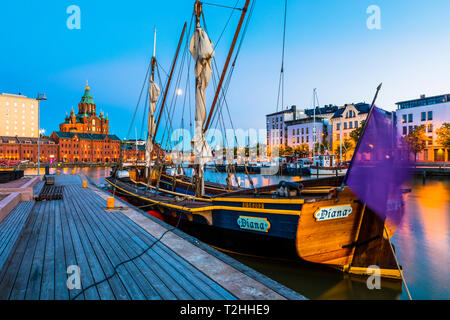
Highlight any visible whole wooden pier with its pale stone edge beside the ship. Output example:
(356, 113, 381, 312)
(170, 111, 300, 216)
(0, 176, 304, 300)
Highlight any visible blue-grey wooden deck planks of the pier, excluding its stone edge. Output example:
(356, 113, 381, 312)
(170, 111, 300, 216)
(0, 176, 243, 300)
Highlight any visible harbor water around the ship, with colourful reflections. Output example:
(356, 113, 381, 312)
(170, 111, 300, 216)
(25, 168, 450, 300)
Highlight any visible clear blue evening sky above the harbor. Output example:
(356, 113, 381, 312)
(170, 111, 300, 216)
(0, 0, 450, 138)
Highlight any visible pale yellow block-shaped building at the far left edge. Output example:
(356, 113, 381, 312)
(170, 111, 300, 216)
(0, 93, 39, 138)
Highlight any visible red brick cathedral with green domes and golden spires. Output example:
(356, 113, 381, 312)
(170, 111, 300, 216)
(59, 85, 109, 134)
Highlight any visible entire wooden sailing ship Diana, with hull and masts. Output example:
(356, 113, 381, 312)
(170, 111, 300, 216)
(106, 0, 401, 279)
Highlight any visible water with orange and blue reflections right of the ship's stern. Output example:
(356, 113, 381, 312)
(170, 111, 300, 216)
(393, 178, 450, 299)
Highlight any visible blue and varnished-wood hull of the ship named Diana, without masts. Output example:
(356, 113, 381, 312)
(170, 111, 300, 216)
(107, 179, 400, 279)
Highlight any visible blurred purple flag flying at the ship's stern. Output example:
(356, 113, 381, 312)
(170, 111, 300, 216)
(345, 107, 409, 226)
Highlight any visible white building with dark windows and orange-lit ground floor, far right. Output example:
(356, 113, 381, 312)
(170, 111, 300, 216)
(396, 94, 450, 162)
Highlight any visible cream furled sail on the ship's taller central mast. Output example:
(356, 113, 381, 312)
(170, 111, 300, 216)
(189, 23, 214, 194)
